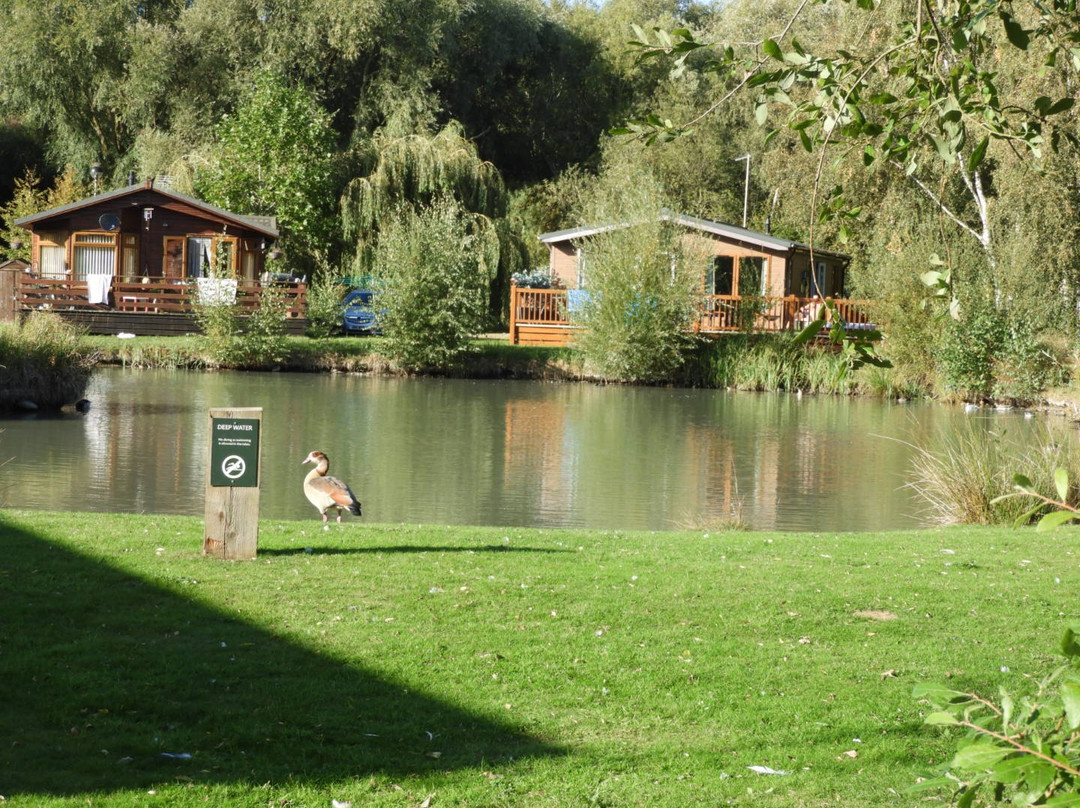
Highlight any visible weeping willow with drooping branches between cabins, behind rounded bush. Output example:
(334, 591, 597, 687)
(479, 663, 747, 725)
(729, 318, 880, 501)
(341, 122, 523, 315)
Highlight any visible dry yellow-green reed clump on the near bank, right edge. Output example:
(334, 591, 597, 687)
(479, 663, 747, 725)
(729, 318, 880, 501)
(908, 418, 1080, 525)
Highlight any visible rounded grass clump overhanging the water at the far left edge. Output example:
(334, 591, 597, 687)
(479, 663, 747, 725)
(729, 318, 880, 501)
(0, 311, 96, 409)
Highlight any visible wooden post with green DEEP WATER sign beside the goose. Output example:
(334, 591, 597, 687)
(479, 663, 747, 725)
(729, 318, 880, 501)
(203, 407, 262, 558)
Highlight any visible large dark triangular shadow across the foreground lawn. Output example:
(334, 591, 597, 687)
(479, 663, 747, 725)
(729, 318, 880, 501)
(0, 517, 562, 799)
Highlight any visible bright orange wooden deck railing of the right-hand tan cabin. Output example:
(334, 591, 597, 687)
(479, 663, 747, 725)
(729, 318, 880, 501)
(510, 286, 873, 342)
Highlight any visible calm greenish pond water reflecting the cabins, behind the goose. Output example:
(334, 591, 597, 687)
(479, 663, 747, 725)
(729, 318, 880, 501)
(0, 369, 1034, 531)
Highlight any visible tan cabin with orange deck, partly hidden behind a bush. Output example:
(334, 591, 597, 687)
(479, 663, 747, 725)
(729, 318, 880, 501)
(510, 212, 870, 345)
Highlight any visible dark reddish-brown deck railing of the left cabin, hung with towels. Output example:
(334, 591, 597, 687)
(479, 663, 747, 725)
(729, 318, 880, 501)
(18, 275, 308, 318)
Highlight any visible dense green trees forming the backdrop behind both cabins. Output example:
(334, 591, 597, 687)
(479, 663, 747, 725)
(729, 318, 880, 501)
(0, 0, 1080, 399)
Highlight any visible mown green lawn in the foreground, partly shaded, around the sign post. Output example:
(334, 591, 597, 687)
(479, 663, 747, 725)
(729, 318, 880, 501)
(0, 511, 1080, 808)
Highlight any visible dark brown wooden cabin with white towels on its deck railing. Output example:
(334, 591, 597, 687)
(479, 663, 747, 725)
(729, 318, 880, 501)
(13, 180, 306, 335)
